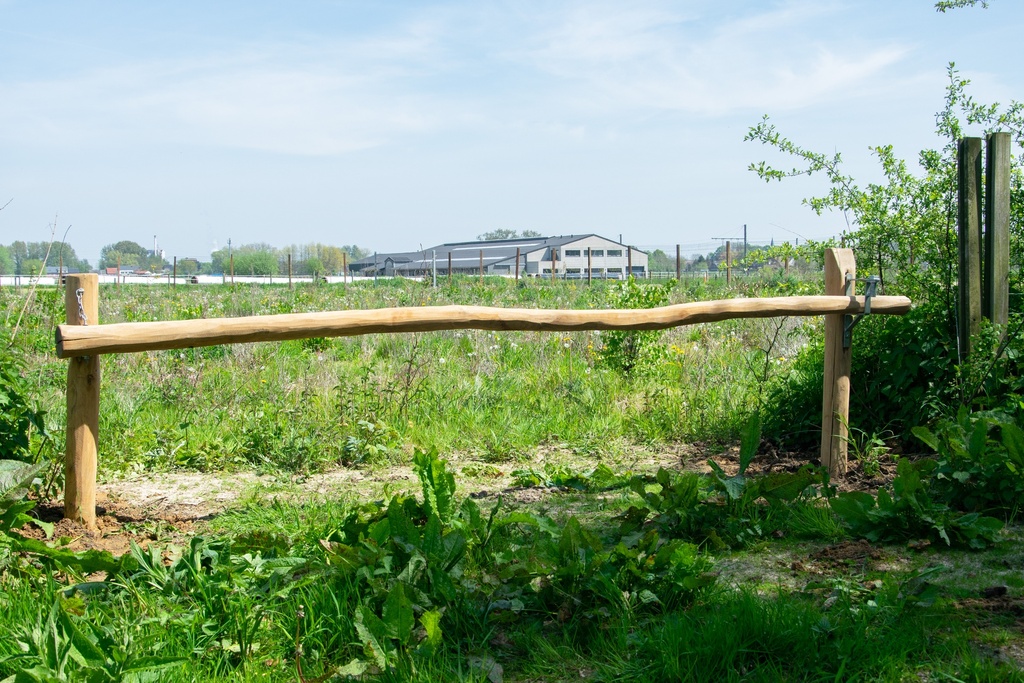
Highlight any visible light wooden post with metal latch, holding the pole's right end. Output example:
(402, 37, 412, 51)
(815, 249, 857, 479)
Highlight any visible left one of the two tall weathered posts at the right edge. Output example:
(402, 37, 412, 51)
(956, 137, 981, 359)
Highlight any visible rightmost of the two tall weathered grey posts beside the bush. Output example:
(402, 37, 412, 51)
(981, 133, 1010, 326)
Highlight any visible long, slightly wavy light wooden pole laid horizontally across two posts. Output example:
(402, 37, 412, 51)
(56, 296, 910, 358)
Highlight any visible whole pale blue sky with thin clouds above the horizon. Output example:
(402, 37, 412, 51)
(0, 0, 1024, 265)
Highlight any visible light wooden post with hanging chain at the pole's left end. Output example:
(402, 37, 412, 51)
(65, 272, 99, 529)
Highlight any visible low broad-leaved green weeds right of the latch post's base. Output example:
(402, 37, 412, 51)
(829, 458, 1002, 549)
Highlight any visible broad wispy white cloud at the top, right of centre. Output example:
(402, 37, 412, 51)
(521, 2, 907, 116)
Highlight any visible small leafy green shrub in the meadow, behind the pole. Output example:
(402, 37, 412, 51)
(599, 275, 676, 376)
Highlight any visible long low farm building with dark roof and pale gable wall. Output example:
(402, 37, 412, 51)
(348, 234, 647, 280)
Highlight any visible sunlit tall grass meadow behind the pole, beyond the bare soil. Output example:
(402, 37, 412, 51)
(0, 279, 814, 473)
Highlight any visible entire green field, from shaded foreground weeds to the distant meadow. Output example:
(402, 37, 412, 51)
(0, 276, 1024, 682)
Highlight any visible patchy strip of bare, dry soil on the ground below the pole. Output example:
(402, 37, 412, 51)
(14, 443, 895, 555)
